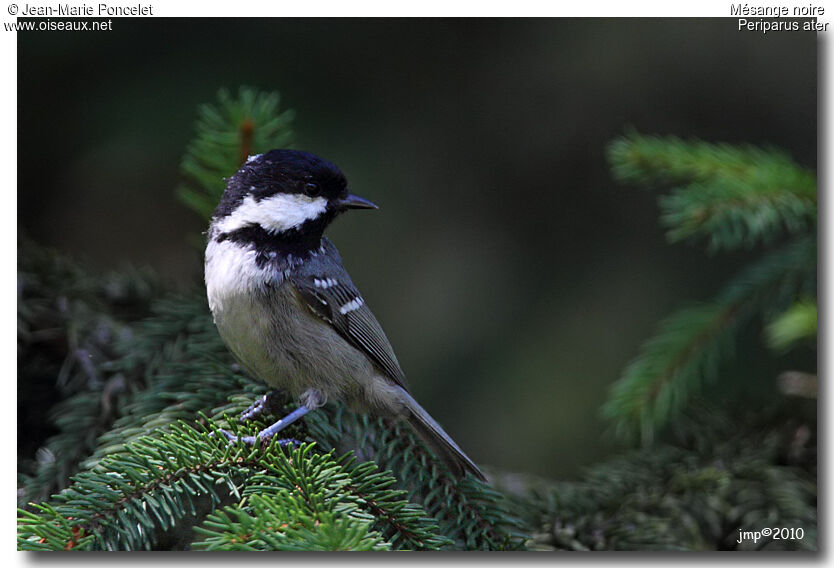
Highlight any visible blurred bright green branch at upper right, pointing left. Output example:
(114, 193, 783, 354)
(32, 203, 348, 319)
(609, 132, 817, 251)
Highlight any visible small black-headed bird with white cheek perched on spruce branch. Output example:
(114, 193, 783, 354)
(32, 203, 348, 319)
(205, 149, 486, 481)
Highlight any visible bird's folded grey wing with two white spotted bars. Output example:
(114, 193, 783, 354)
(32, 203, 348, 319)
(289, 241, 408, 390)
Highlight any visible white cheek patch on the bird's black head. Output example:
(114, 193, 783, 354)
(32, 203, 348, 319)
(217, 193, 327, 233)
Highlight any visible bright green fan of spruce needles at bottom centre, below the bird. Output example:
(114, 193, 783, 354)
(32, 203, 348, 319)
(196, 446, 450, 550)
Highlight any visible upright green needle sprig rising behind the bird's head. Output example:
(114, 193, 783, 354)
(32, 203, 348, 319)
(177, 87, 295, 220)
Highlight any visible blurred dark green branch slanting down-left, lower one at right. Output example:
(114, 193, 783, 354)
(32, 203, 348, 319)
(602, 235, 816, 444)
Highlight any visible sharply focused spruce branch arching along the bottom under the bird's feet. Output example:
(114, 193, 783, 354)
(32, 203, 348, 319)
(19, 422, 445, 550)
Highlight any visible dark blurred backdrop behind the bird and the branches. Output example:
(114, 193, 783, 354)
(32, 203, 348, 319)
(18, 19, 817, 477)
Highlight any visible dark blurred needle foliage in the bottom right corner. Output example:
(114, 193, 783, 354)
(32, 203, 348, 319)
(497, 408, 817, 550)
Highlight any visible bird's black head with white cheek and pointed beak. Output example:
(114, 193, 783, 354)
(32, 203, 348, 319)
(212, 150, 376, 255)
